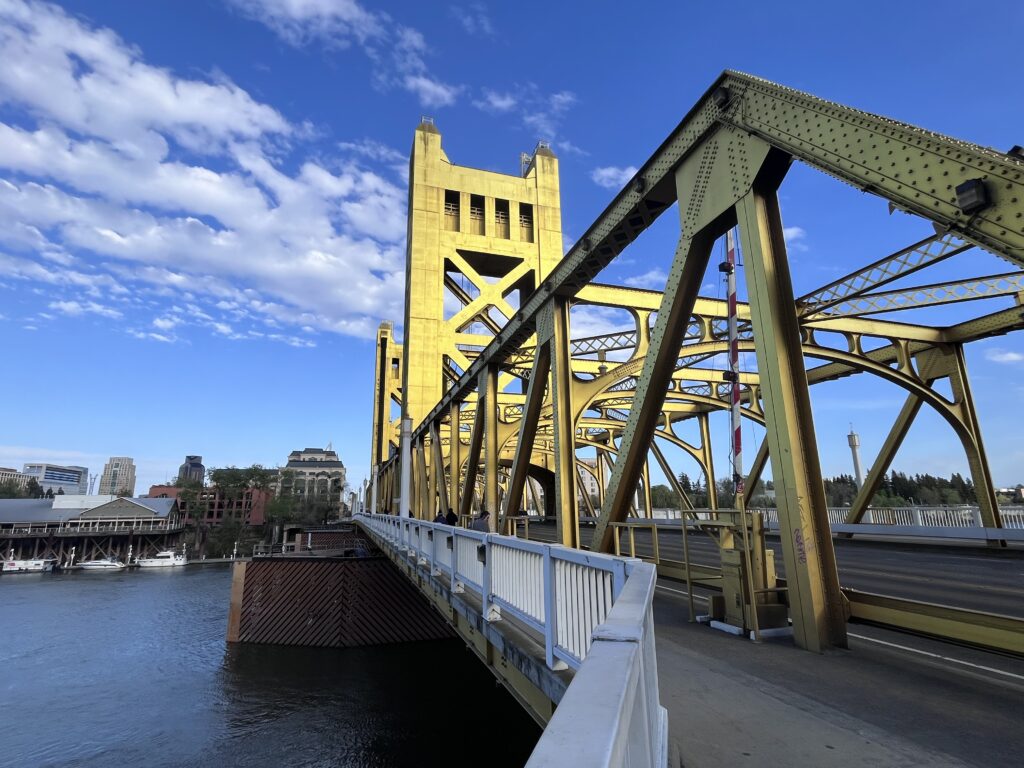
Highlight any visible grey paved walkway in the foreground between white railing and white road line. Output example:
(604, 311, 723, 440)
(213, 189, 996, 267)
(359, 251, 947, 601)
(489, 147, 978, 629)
(654, 593, 1024, 768)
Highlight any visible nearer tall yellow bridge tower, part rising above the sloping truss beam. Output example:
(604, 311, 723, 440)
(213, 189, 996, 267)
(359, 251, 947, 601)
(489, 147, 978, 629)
(401, 119, 563, 426)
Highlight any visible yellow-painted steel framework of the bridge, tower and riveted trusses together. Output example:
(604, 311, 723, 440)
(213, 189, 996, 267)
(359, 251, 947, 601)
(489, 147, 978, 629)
(372, 73, 1024, 648)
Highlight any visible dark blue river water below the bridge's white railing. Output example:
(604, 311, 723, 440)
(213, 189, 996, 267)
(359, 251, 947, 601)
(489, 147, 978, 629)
(0, 566, 540, 768)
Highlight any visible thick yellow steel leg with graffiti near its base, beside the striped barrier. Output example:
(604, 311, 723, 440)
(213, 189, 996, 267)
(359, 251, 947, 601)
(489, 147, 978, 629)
(736, 183, 847, 652)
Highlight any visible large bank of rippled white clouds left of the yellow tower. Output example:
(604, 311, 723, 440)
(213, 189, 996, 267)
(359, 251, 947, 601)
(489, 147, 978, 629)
(0, 0, 407, 344)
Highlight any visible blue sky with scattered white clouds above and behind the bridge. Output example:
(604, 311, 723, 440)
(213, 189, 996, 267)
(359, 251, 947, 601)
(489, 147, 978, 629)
(0, 0, 1024, 492)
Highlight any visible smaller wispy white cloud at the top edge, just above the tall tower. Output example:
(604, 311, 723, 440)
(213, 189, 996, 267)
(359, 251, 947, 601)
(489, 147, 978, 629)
(228, 0, 462, 108)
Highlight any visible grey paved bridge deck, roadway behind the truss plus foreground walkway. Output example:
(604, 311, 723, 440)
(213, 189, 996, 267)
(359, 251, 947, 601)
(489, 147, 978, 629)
(530, 524, 1024, 768)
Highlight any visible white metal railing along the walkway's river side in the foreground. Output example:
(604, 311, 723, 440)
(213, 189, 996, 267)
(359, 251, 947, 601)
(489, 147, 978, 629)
(354, 514, 669, 768)
